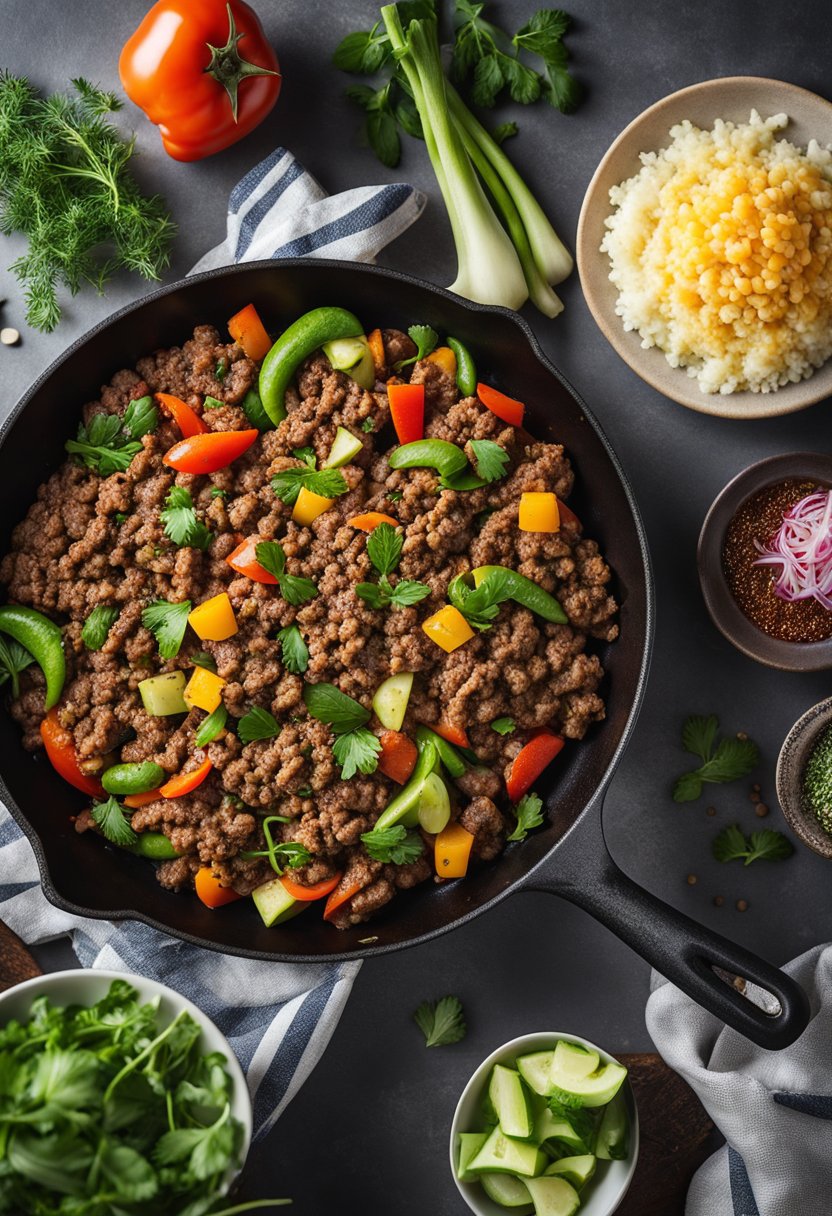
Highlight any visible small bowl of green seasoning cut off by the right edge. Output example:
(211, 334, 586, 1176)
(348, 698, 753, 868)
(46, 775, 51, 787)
(776, 697, 832, 858)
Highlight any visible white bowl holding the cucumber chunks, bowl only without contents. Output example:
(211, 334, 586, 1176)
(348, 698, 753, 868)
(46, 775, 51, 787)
(450, 1030, 639, 1216)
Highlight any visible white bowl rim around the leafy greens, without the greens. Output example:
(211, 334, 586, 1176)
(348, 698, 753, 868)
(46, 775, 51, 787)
(0, 969, 252, 1198)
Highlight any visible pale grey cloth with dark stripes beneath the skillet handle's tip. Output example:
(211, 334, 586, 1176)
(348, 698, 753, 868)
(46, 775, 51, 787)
(647, 945, 832, 1216)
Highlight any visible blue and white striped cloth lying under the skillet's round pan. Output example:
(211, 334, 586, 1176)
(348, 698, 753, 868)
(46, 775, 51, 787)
(0, 148, 425, 1139)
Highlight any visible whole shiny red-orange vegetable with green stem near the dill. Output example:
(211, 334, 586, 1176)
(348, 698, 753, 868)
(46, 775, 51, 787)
(118, 0, 281, 161)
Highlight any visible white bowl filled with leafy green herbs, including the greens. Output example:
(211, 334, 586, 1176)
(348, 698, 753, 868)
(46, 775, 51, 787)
(0, 970, 252, 1216)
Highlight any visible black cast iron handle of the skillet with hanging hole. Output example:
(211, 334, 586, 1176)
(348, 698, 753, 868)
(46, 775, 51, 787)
(524, 807, 810, 1051)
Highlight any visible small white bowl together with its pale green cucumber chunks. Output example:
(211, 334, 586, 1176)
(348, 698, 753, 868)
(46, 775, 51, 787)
(450, 1034, 639, 1216)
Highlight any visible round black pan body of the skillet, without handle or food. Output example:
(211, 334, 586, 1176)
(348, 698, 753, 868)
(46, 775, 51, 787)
(0, 259, 652, 961)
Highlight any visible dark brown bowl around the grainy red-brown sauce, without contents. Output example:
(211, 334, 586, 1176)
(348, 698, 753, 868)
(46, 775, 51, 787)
(696, 452, 832, 671)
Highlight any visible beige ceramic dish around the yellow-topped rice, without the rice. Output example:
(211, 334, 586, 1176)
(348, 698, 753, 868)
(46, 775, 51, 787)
(577, 77, 832, 418)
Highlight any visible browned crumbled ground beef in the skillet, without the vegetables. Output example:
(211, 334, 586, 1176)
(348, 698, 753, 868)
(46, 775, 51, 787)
(0, 326, 618, 927)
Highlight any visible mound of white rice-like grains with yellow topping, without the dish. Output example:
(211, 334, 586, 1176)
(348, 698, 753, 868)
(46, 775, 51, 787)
(601, 111, 832, 393)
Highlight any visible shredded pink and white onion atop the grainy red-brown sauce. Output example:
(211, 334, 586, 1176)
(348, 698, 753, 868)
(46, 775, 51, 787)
(754, 490, 832, 612)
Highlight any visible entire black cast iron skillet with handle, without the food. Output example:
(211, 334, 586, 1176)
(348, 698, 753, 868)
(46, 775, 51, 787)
(0, 259, 808, 1048)
